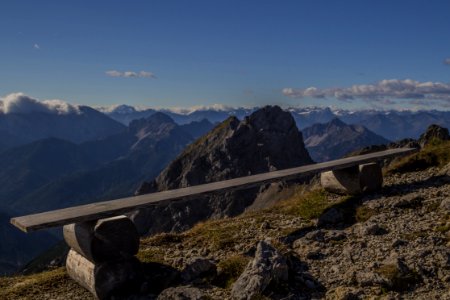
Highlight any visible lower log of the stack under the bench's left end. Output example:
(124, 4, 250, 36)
(66, 249, 142, 299)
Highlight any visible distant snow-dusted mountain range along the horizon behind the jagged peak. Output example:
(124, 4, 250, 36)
(102, 105, 450, 140)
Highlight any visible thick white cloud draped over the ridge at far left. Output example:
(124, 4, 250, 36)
(0, 93, 81, 114)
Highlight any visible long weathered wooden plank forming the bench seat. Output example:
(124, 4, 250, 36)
(11, 148, 416, 232)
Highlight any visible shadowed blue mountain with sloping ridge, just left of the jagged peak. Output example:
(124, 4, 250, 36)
(10, 113, 193, 213)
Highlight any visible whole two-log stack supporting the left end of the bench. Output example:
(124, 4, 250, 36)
(63, 216, 141, 299)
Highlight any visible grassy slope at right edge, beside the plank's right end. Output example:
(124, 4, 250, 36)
(386, 141, 450, 174)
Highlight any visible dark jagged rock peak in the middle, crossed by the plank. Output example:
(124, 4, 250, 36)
(133, 106, 313, 233)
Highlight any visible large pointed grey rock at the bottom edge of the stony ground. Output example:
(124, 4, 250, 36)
(231, 241, 288, 299)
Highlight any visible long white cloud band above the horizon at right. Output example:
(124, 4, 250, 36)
(282, 79, 450, 102)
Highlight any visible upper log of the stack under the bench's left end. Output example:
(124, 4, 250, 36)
(63, 216, 139, 263)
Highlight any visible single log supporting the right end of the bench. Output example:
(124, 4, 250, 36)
(320, 163, 383, 195)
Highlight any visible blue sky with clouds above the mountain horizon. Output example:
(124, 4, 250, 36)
(0, 0, 450, 109)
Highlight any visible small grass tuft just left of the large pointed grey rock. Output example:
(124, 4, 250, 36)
(213, 255, 250, 288)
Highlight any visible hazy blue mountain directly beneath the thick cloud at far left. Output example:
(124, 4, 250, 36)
(0, 106, 125, 148)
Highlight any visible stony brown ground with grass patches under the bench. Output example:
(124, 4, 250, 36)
(0, 167, 450, 299)
